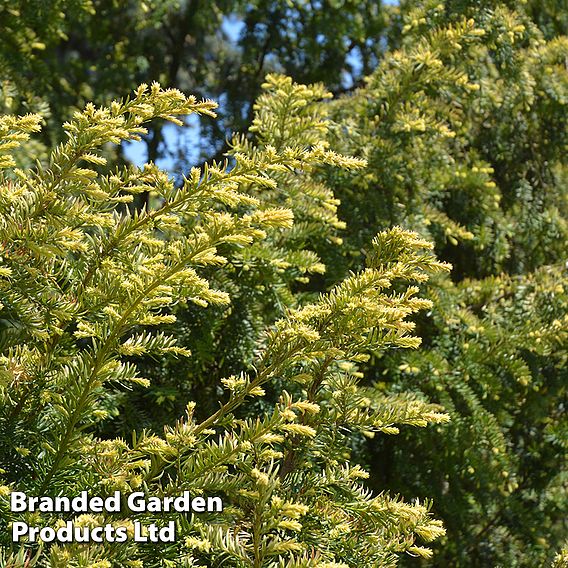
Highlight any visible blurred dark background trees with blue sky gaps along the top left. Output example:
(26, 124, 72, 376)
(0, 0, 385, 167)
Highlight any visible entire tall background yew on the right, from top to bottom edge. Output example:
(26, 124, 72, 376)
(320, 2, 568, 567)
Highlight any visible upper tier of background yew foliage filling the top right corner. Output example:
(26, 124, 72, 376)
(328, 2, 568, 279)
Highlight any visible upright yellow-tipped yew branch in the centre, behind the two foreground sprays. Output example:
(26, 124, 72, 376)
(118, 75, 364, 432)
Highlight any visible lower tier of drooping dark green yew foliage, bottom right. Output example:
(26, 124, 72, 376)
(375, 267, 568, 567)
